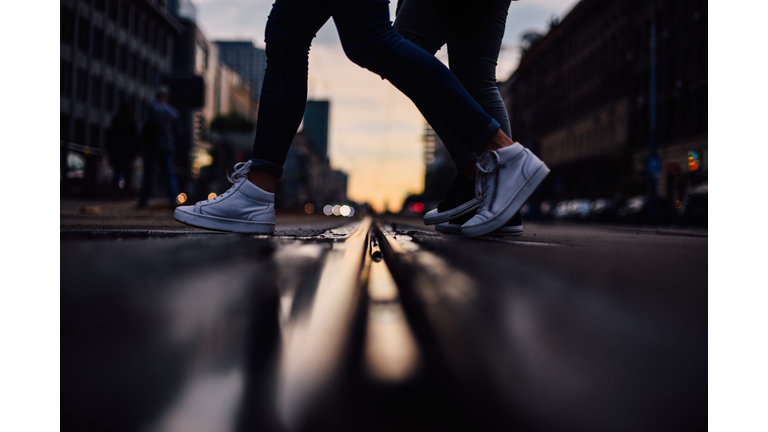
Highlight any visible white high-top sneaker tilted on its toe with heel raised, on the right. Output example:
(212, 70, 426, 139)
(461, 143, 549, 237)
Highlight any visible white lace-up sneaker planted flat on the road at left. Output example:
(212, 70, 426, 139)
(173, 161, 275, 234)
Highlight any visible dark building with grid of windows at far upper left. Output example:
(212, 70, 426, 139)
(60, 0, 182, 193)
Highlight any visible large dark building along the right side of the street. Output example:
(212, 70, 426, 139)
(501, 0, 708, 200)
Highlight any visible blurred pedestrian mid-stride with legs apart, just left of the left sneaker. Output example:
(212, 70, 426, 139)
(138, 86, 182, 208)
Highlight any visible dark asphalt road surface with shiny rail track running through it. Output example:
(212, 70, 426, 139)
(60, 202, 708, 431)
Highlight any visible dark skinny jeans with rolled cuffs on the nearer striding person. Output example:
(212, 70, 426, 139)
(251, 0, 499, 177)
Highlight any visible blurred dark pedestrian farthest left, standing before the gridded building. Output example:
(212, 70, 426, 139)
(106, 101, 138, 199)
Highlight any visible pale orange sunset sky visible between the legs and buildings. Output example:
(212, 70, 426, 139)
(193, 0, 578, 211)
